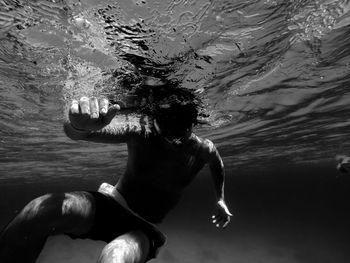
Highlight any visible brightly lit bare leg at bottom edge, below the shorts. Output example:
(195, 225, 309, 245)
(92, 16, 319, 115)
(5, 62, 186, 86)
(98, 230, 150, 263)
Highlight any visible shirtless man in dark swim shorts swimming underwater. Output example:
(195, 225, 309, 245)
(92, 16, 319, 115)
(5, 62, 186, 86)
(0, 97, 232, 263)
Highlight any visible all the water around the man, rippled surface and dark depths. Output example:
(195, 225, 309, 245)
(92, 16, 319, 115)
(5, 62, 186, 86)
(0, 0, 350, 263)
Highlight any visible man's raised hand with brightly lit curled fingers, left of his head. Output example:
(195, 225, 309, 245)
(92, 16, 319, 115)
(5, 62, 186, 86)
(69, 97, 120, 131)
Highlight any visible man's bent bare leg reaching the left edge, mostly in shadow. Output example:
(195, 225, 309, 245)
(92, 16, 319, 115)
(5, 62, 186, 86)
(0, 192, 95, 263)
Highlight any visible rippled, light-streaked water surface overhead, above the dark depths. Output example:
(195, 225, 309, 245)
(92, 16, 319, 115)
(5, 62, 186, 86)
(0, 0, 350, 179)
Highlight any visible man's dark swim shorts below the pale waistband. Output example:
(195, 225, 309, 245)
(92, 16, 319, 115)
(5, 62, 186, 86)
(68, 192, 166, 260)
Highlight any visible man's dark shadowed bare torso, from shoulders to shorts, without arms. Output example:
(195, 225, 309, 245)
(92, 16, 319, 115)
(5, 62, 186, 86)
(117, 134, 211, 223)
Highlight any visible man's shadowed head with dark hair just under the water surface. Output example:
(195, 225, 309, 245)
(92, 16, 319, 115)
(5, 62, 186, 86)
(135, 80, 202, 143)
